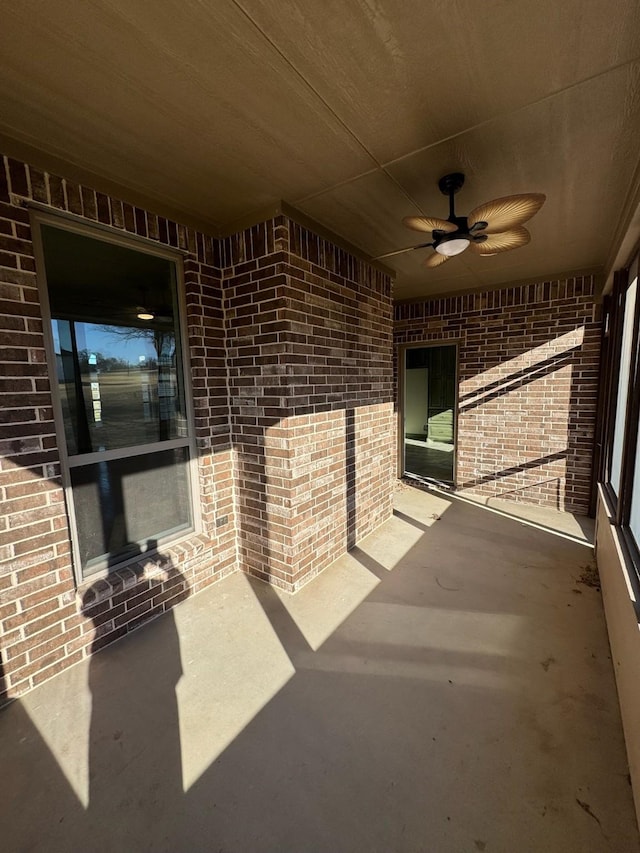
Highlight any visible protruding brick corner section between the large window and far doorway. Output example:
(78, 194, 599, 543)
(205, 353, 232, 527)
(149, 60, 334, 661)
(221, 217, 394, 591)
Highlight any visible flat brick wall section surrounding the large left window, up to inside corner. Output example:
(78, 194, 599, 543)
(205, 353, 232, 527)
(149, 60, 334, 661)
(0, 157, 236, 703)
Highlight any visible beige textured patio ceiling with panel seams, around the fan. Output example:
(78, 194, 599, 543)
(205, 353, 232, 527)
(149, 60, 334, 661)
(0, 0, 640, 299)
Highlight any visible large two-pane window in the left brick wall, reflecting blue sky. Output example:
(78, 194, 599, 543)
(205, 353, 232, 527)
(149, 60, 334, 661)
(34, 217, 194, 577)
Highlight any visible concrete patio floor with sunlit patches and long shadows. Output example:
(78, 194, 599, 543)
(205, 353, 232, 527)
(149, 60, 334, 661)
(0, 486, 640, 853)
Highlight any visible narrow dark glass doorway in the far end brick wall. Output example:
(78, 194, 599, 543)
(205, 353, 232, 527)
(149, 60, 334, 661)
(402, 344, 458, 485)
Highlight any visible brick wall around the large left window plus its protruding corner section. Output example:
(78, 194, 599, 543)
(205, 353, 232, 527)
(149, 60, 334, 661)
(0, 151, 394, 704)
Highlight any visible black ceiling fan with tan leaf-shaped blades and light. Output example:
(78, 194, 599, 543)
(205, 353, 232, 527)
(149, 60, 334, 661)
(374, 172, 546, 267)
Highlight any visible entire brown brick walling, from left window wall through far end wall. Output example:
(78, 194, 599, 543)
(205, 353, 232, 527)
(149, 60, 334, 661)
(0, 158, 599, 702)
